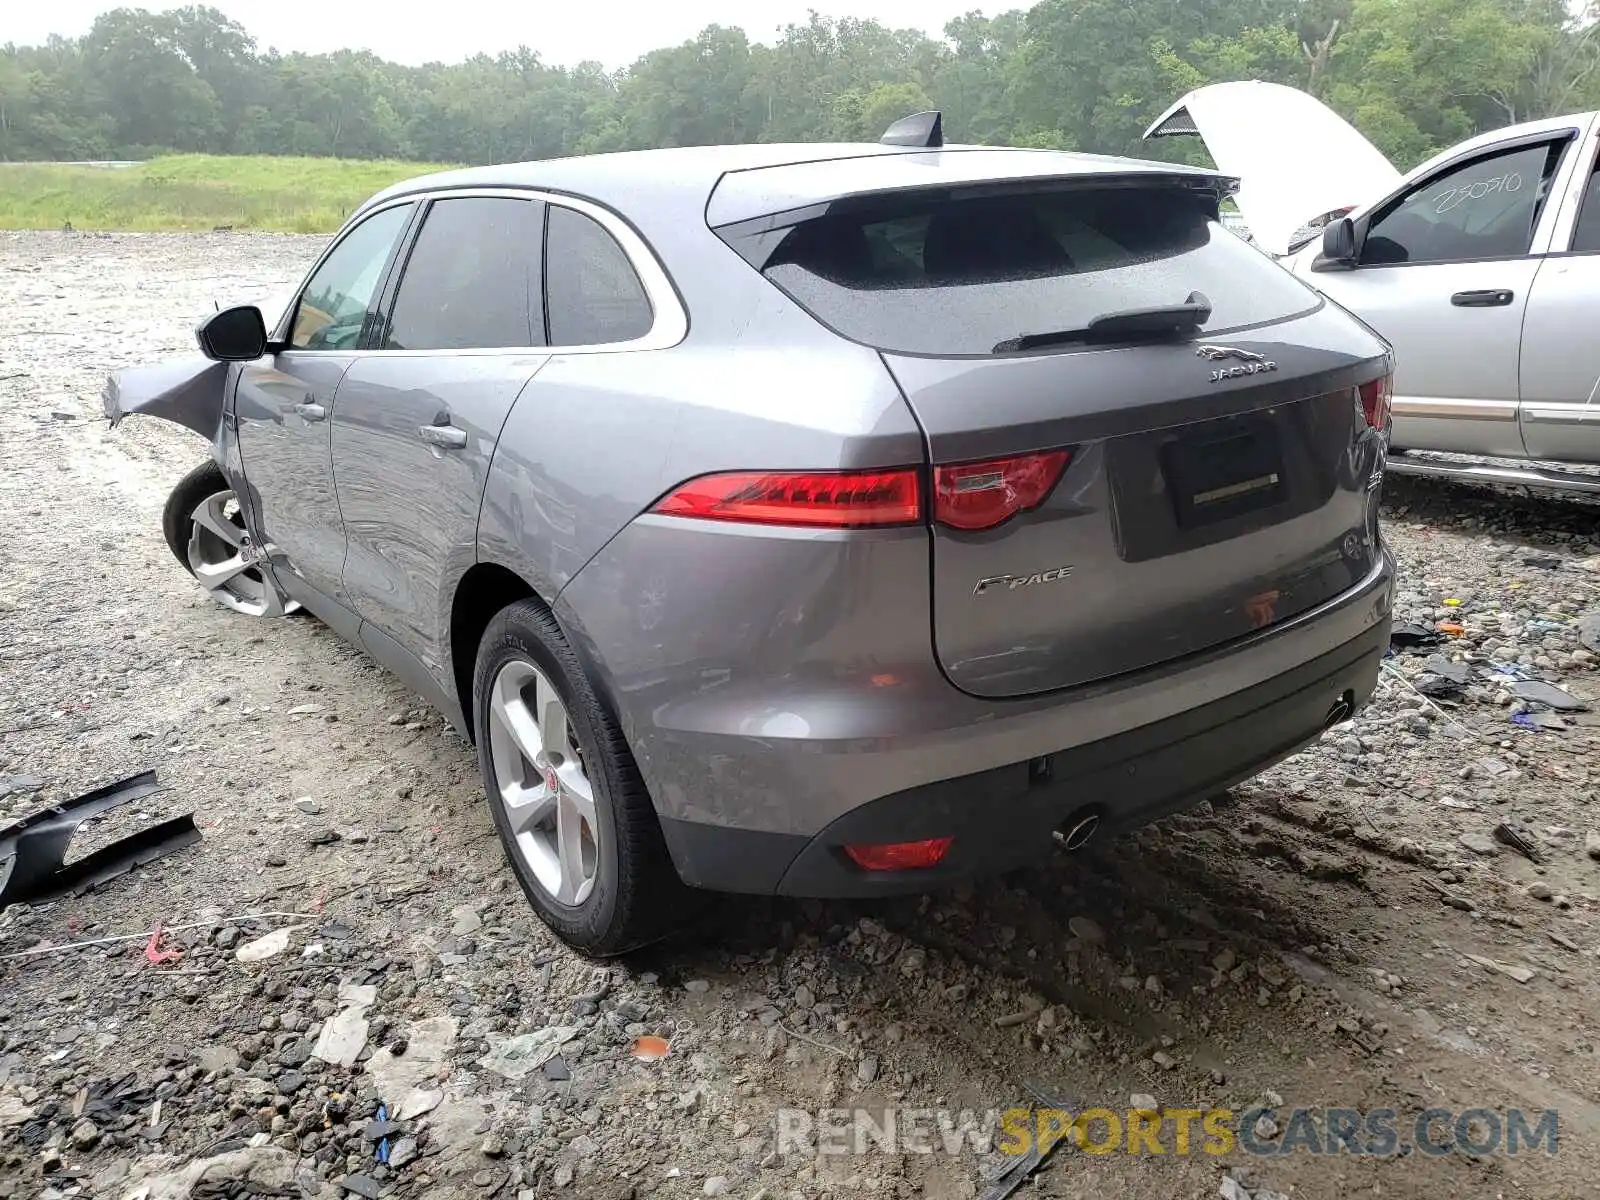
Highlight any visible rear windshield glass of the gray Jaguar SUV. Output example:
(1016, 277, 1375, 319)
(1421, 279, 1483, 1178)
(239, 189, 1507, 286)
(736, 186, 1318, 355)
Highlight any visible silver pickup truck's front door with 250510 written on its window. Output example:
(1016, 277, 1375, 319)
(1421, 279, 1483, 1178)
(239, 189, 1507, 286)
(1310, 138, 1568, 458)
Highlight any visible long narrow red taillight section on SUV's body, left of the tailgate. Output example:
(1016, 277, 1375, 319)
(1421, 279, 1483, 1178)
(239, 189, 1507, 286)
(654, 467, 922, 530)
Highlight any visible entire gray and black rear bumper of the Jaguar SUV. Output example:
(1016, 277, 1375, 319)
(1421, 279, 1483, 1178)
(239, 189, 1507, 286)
(554, 502, 1394, 894)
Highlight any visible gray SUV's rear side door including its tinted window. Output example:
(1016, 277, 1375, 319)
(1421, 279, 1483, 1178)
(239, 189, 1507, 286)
(333, 194, 549, 691)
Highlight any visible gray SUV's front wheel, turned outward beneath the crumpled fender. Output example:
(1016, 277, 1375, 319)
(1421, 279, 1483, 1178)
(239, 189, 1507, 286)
(162, 461, 298, 616)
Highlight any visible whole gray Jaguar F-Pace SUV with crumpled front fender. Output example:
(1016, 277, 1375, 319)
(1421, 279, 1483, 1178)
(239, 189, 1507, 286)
(106, 114, 1394, 955)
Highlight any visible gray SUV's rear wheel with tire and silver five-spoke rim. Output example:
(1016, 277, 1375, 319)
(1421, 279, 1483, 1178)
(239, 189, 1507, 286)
(472, 600, 686, 957)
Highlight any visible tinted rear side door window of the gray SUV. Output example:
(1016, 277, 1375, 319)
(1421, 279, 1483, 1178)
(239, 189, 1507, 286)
(381, 197, 544, 350)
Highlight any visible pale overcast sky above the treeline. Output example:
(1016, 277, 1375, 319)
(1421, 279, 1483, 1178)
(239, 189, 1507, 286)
(9, 0, 985, 67)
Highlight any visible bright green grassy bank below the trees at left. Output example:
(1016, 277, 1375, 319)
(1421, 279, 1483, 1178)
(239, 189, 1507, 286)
(0, 154, 460, 234)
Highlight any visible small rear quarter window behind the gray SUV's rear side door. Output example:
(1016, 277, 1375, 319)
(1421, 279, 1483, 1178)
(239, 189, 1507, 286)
(544, 205, 654, 346)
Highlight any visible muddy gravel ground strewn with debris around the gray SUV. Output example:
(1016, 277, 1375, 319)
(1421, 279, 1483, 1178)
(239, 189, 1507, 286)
(0, 234, 1600, 1200)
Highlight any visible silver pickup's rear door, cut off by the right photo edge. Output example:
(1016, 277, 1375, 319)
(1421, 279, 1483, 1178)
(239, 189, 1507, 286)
(1518, 120, 1600, 462)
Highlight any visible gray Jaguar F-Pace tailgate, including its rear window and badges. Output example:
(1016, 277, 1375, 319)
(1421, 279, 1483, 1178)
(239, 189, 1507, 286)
(725, 180, 1387, 696)
